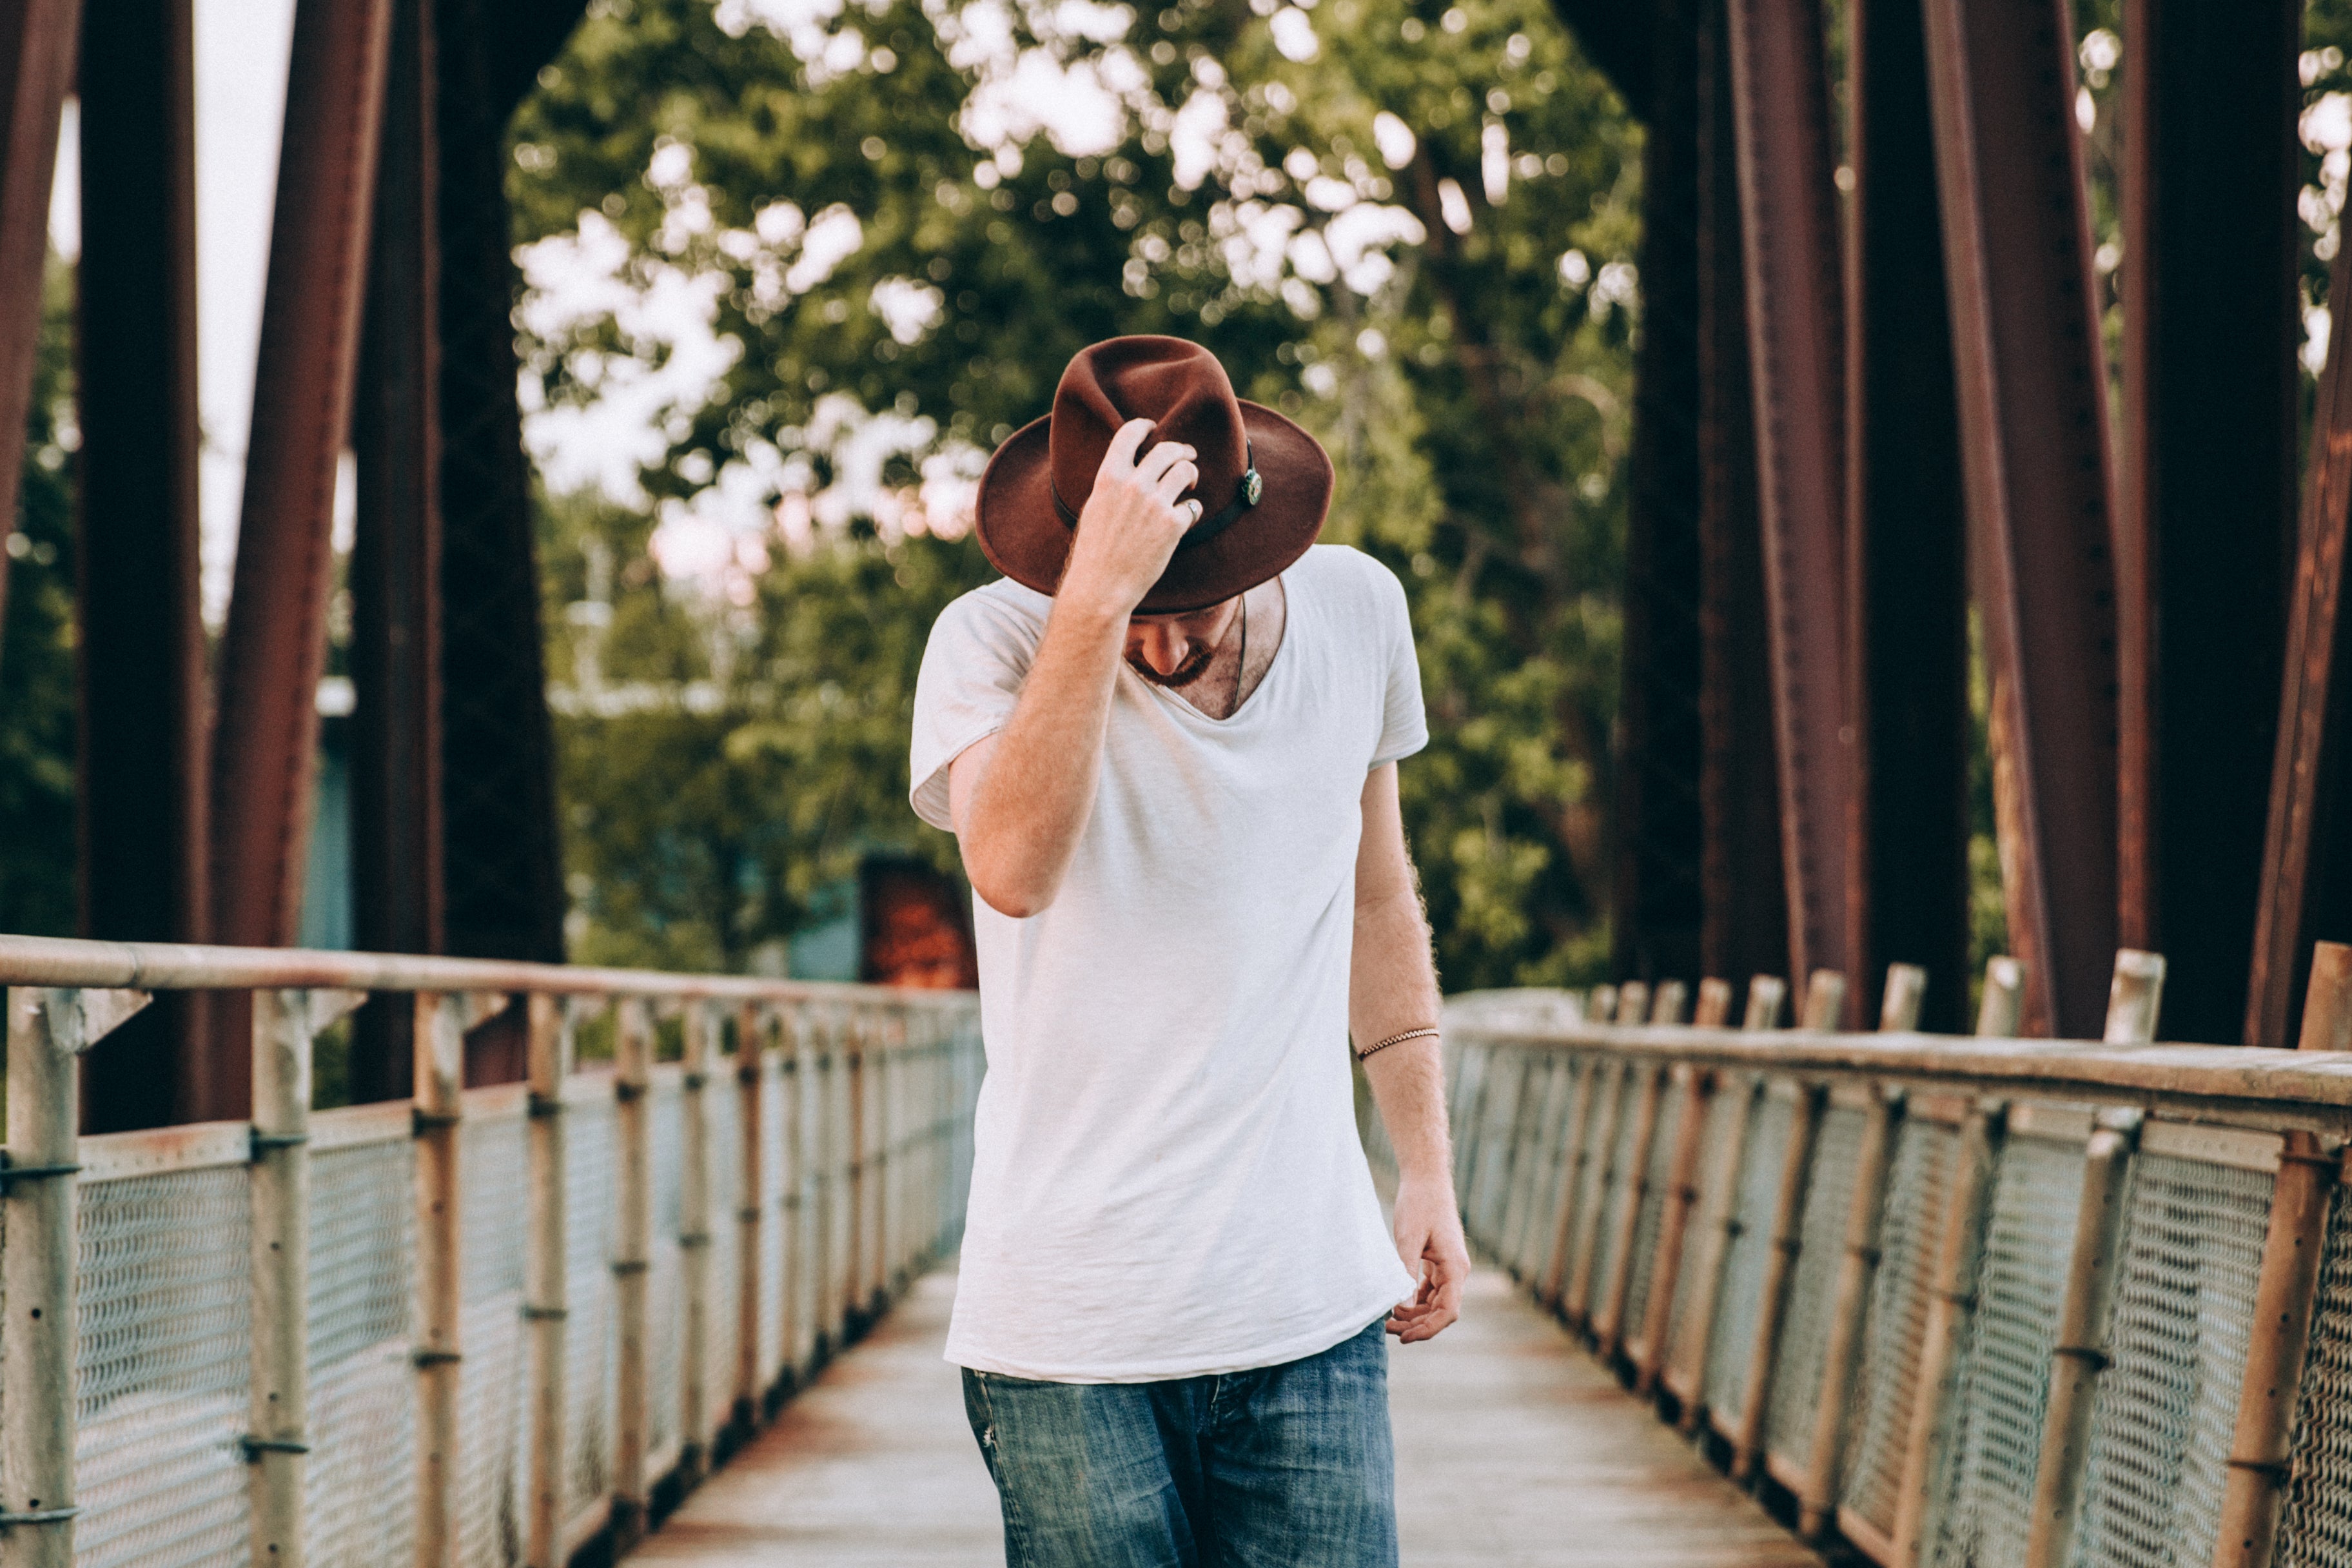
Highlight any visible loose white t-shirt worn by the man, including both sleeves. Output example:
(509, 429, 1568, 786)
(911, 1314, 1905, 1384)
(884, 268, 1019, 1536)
(912, 545, 1427, 1382)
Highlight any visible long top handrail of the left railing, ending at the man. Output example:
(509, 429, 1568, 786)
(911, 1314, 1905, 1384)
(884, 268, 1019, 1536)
(0, 936, 962, 1006)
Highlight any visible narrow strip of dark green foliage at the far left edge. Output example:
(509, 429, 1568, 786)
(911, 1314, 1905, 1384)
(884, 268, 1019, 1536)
(0, 261, 80, 936)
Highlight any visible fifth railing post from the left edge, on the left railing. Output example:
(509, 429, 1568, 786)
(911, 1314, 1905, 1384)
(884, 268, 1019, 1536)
(611, 997, 654, 1556)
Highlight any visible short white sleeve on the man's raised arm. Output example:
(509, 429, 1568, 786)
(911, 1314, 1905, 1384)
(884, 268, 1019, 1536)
(908, 583, 1052, 832)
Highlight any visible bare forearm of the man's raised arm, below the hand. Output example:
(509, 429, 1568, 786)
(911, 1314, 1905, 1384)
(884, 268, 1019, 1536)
(959, 600, 1126, 917)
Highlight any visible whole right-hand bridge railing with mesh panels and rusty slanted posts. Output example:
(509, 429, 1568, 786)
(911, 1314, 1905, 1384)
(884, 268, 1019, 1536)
(1373, 947, 2352, 1568)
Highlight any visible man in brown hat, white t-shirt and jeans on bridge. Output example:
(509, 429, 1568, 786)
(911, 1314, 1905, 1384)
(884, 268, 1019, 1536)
(912, 338, 1467, 1568)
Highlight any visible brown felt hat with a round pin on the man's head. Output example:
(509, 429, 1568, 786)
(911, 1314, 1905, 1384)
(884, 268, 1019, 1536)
(979, 338, 1331, 616)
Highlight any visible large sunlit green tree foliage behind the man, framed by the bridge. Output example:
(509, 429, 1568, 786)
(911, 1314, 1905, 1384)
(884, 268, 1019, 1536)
(511, 0, 1640, 985)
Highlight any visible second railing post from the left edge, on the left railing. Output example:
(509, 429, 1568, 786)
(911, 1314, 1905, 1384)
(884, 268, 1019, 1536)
(244, 990, 337, 1568)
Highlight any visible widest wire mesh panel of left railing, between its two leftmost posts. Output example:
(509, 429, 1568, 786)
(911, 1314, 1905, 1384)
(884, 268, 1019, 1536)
(73, 1166, 254, 1568)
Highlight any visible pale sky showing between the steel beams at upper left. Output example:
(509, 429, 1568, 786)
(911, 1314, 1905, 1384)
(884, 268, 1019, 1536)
(50, 0, 299, 623)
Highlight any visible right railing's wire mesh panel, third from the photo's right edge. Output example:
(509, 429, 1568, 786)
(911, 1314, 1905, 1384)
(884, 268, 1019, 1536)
(1934, 1138, 2084, 1568)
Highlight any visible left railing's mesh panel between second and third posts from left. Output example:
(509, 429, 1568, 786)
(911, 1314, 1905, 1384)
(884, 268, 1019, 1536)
(304, 1138, 416, 1568)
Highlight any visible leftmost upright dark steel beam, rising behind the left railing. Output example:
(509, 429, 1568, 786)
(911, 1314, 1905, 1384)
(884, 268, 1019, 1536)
(75, 0, 211, 1131)
